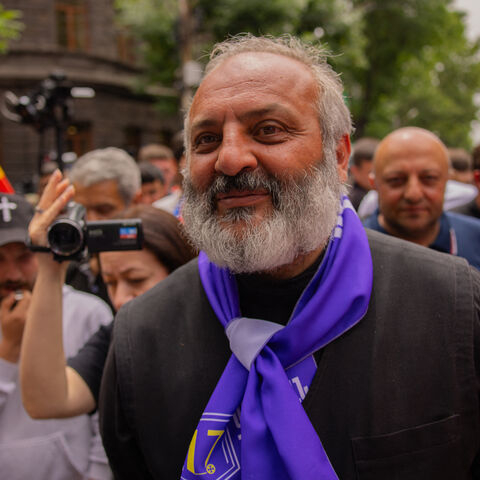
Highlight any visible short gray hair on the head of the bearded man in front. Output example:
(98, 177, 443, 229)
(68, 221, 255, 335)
(185, 33, 352, 158)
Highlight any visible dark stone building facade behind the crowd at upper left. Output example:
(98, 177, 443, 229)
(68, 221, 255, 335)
(0, 0, 181, 191)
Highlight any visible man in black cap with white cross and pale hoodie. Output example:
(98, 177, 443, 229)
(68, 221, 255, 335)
(0, 194, 111, 480)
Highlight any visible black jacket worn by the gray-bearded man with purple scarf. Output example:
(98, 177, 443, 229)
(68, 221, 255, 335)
(100, 232, 480, 480)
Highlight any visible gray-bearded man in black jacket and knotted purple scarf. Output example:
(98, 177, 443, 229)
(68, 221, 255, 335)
(100, 35, 480, 480)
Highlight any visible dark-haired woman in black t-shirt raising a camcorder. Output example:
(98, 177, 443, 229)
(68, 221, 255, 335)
(20, 172, 195, 418)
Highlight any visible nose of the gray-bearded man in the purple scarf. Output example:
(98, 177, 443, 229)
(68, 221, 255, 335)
(215, 128, 258, 177)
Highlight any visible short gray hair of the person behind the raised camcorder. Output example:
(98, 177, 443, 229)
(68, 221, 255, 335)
(68, 147, 141, 205)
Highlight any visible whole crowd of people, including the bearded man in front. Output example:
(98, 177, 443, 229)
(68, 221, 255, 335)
(0, 31, 480, 480)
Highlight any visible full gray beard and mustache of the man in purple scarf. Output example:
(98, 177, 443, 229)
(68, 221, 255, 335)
(182, 152, 345, 273)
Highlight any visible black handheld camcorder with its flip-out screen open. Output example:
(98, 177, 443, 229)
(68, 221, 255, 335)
(42, 202, 143, 262)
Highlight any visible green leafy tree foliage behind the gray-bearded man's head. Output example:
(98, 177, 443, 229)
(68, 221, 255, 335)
(117, 0, 480, 148)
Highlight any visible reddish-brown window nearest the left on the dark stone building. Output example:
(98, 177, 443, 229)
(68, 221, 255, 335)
(55, 0, 88, 50)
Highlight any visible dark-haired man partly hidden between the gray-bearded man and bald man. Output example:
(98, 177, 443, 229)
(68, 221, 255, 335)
(348, 137, 378, 210)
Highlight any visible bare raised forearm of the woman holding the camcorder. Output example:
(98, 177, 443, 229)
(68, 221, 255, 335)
(20, 254, 67, 418)
